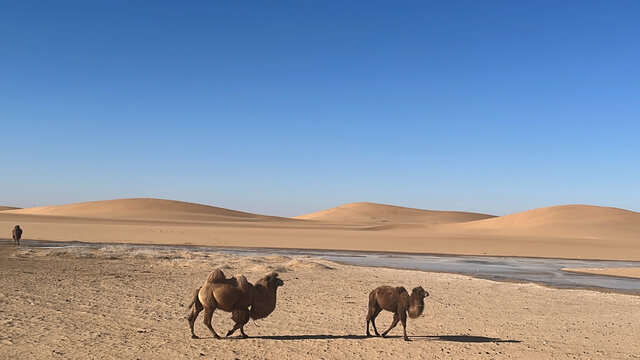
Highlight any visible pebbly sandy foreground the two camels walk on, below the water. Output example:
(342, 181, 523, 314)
(0, 242, 640, 359)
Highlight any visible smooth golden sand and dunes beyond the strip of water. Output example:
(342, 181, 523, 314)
(0, 199, 640, 261)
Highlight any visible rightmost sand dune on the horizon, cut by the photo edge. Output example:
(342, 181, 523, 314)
(460, 205, 640, 238)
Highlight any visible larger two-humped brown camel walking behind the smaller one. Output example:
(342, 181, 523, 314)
(189, 269, 284, 339)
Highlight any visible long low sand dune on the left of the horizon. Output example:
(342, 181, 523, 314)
(6, 198, 284, 220)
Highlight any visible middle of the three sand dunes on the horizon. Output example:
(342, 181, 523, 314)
(295, 202, 493, 224)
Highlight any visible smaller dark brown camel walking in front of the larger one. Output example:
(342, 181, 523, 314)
(367, 286, 429, 341)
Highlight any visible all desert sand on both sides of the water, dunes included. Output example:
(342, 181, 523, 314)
(0, 199, 640, 359)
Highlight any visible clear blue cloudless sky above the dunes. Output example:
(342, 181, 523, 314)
(0, 0, 640, 216)
